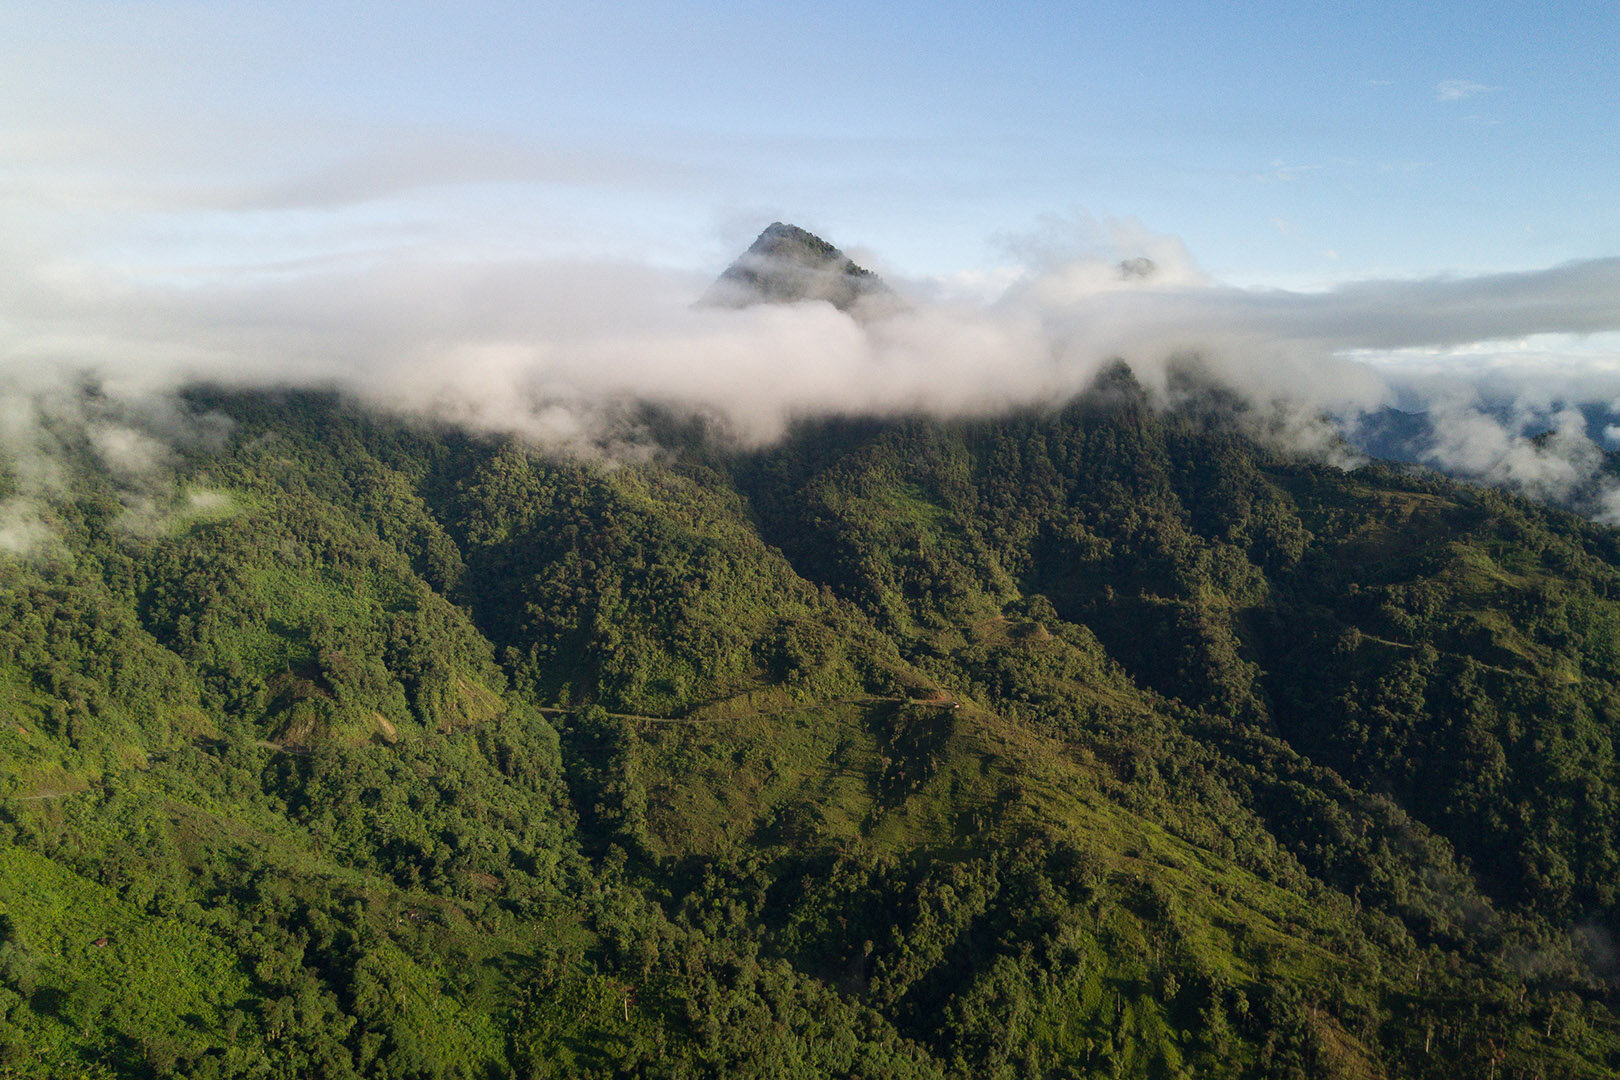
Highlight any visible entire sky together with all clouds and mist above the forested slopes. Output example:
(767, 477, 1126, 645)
(12, 0, 1620, 551)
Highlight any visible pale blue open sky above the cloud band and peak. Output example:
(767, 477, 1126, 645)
(0, 2, 1620, 288)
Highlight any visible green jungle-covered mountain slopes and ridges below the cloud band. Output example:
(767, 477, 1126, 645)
(0, 368, 1620, 1080)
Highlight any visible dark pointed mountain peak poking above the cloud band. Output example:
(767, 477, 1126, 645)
(703, 222, 897, 313)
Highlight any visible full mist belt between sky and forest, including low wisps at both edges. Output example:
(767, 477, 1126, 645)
(0, 221, 1620, 540)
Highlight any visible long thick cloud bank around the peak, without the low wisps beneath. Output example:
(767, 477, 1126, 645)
(0, 222, 1620, 440)
